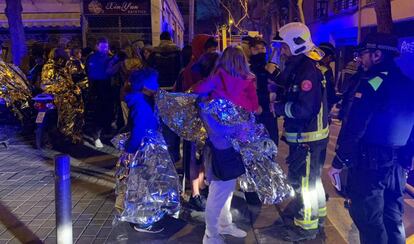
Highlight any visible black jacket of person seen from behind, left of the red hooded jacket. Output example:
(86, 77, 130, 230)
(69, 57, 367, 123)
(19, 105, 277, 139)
(148, 40, 181, 89)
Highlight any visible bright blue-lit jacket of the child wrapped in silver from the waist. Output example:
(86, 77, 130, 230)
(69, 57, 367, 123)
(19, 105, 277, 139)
(125, 92, 159, 153)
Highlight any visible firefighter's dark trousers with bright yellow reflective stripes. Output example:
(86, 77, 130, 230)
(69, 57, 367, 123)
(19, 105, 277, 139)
(284, 139, 328, 230)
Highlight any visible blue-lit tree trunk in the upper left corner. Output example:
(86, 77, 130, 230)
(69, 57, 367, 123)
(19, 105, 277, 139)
(5, 0, 27, 65)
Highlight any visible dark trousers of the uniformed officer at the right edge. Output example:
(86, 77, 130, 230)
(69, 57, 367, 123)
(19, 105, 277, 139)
(347, 163, 406, 244)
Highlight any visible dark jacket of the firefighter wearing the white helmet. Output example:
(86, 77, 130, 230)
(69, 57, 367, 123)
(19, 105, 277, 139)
(275, 54, 329, 143)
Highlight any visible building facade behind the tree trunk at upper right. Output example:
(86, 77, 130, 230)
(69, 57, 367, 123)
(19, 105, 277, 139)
(303, 0, 414, 87)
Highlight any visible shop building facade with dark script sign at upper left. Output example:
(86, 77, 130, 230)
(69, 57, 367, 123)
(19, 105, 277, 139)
(0, 0, 184, 47)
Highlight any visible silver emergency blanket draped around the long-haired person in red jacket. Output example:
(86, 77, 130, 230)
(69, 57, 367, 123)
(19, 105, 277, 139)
(157, 93, 294, 204)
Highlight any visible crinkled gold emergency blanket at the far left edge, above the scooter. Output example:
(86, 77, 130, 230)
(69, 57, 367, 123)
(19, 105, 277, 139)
(0, 60, 32, 119)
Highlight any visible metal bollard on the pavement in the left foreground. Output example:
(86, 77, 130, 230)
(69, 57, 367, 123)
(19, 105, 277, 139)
(55, 155, 73, 244)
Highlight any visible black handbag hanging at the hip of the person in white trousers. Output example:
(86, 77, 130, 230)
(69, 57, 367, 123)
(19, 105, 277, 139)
(208, 141, 246, 181)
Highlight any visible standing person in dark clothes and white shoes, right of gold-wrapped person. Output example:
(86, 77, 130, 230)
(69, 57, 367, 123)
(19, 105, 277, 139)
(86, 38, 114, 148)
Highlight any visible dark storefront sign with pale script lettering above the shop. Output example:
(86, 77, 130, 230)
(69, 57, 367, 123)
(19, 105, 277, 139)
(83, 0, 151, 15)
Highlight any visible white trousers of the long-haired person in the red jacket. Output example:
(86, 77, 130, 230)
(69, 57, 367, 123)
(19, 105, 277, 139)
(205, 179, 237, 237)
